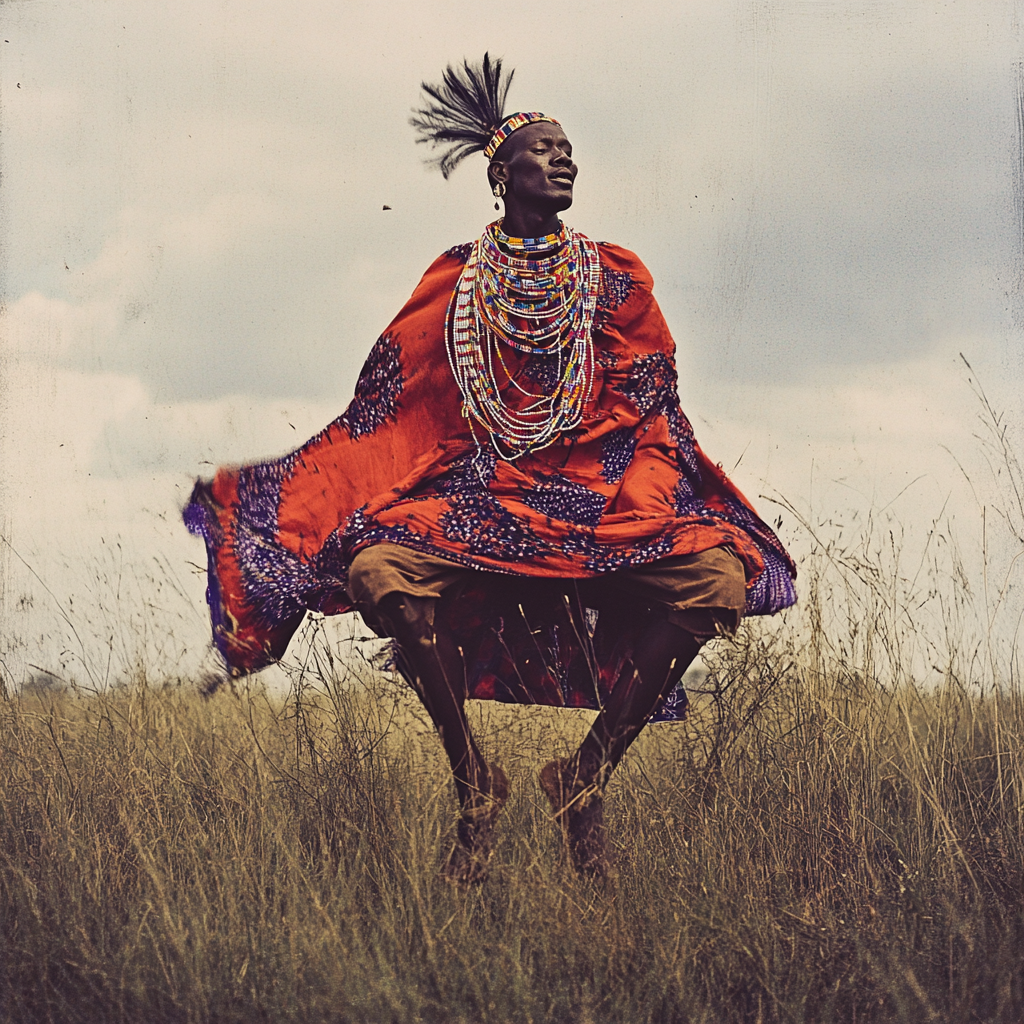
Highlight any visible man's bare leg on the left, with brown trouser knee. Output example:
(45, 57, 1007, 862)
(349, 546, 508, 882)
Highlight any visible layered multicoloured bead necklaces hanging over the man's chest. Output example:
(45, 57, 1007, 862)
(444, 222, 601, 461)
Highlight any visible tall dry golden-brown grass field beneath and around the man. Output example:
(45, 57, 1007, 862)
(0, 378, 1024, 1024)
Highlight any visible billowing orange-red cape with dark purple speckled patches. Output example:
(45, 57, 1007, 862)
(184, 243, 796, 718)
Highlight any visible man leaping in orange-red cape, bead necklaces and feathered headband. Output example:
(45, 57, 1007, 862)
(185, 56, 796, 882)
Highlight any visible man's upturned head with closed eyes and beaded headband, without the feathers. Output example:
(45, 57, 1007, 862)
(492, 121, 578, 211)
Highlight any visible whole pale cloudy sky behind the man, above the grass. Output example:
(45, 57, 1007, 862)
(0, 0, 1024, 684)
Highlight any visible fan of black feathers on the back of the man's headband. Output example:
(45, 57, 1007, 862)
(409, 53, 515, 178)
